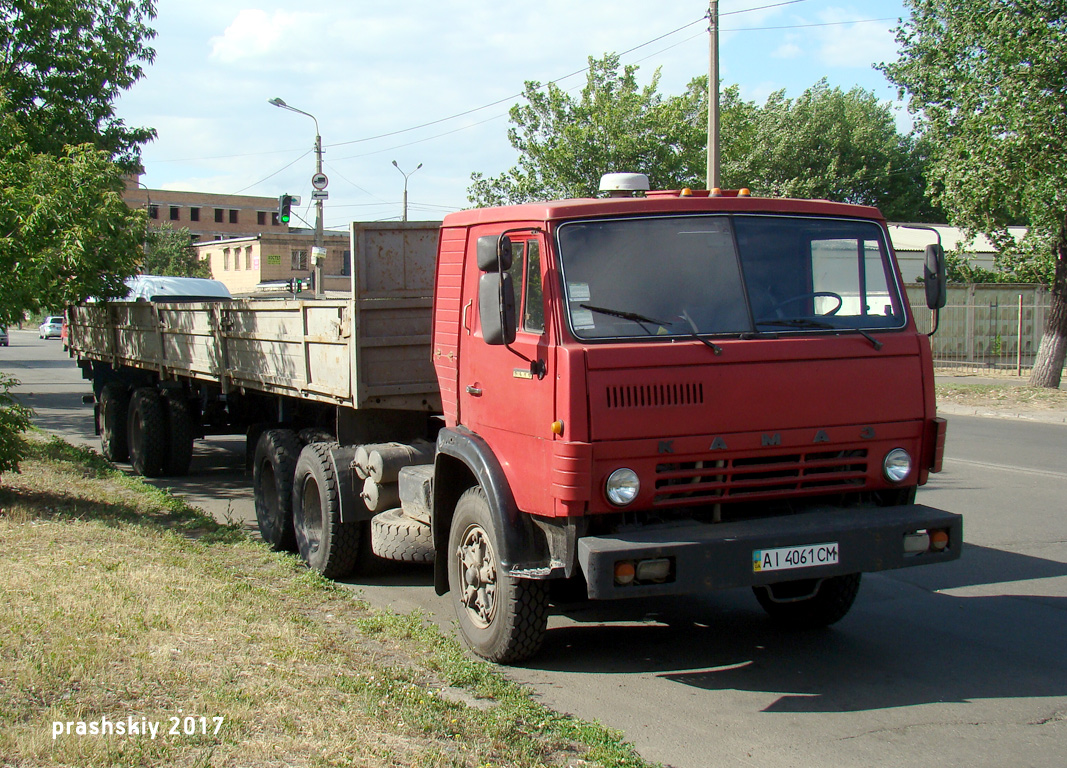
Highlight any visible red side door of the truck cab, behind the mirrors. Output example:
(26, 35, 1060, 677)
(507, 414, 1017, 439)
(459, 228, 556, 514)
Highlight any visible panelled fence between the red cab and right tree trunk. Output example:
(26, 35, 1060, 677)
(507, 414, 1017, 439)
(908, 284, 1051, 377)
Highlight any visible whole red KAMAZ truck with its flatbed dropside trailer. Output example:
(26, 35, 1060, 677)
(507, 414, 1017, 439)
(68, 175, 962, 662)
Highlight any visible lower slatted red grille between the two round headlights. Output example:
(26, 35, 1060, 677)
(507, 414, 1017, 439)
(653, 449, 867, 507)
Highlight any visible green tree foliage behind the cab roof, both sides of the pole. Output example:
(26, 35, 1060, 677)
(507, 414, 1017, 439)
(468, 55, 940, 221)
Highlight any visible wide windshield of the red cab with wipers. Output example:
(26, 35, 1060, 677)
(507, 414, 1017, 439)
(557, 214, 905, 338)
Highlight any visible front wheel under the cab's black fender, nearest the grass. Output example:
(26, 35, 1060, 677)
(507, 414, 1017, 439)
(447, 486, 548, 663)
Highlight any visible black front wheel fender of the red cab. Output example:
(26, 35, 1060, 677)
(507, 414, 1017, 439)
(431, 427, 563, 594)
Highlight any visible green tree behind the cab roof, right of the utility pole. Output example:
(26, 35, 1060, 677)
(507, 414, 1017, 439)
(722, 80, 941, 221)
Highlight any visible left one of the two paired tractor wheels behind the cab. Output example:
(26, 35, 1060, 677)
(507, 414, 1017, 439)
(252, 429, 302, 551)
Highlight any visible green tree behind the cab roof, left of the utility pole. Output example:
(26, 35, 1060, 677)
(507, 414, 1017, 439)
(467, 54, 706, 206)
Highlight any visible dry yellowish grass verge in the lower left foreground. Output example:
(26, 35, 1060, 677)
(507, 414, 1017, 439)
(0, 441, 643, 766)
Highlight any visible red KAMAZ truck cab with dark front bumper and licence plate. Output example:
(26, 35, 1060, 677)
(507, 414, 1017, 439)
(433, 178, 961, 658)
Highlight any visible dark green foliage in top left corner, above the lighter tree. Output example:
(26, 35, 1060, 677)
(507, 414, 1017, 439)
(0, 0, 156, 172)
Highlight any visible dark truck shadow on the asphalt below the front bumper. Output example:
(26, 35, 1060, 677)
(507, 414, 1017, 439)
(529, 546, 1067, 713)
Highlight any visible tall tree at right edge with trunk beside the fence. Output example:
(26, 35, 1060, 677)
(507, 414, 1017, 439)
(882, 0, 1067, 387)
